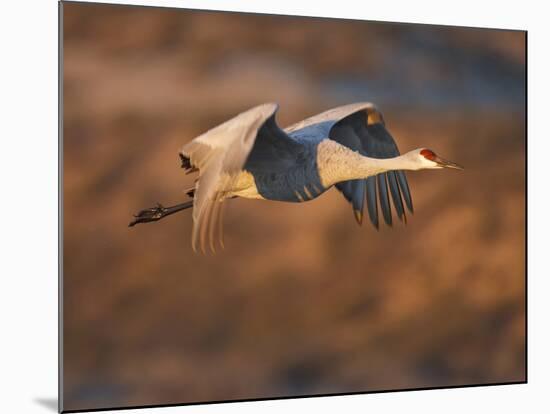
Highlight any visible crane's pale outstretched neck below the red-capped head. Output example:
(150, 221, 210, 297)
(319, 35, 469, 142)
(317, 140, 418, 188)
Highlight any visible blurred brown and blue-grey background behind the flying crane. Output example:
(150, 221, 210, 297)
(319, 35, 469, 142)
(63, 3, 526, 410)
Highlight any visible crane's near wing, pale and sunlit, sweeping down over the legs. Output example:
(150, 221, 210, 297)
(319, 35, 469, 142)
(180, 103, 299, 252)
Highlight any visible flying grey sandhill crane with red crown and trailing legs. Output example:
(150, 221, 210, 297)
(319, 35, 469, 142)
(129, 102, 463, 253)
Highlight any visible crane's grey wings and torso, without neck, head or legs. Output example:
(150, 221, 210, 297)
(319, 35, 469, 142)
(181, 102, 418, 249)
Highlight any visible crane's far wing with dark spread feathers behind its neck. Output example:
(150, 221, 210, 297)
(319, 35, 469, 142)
(329, 103, 413, 228)
